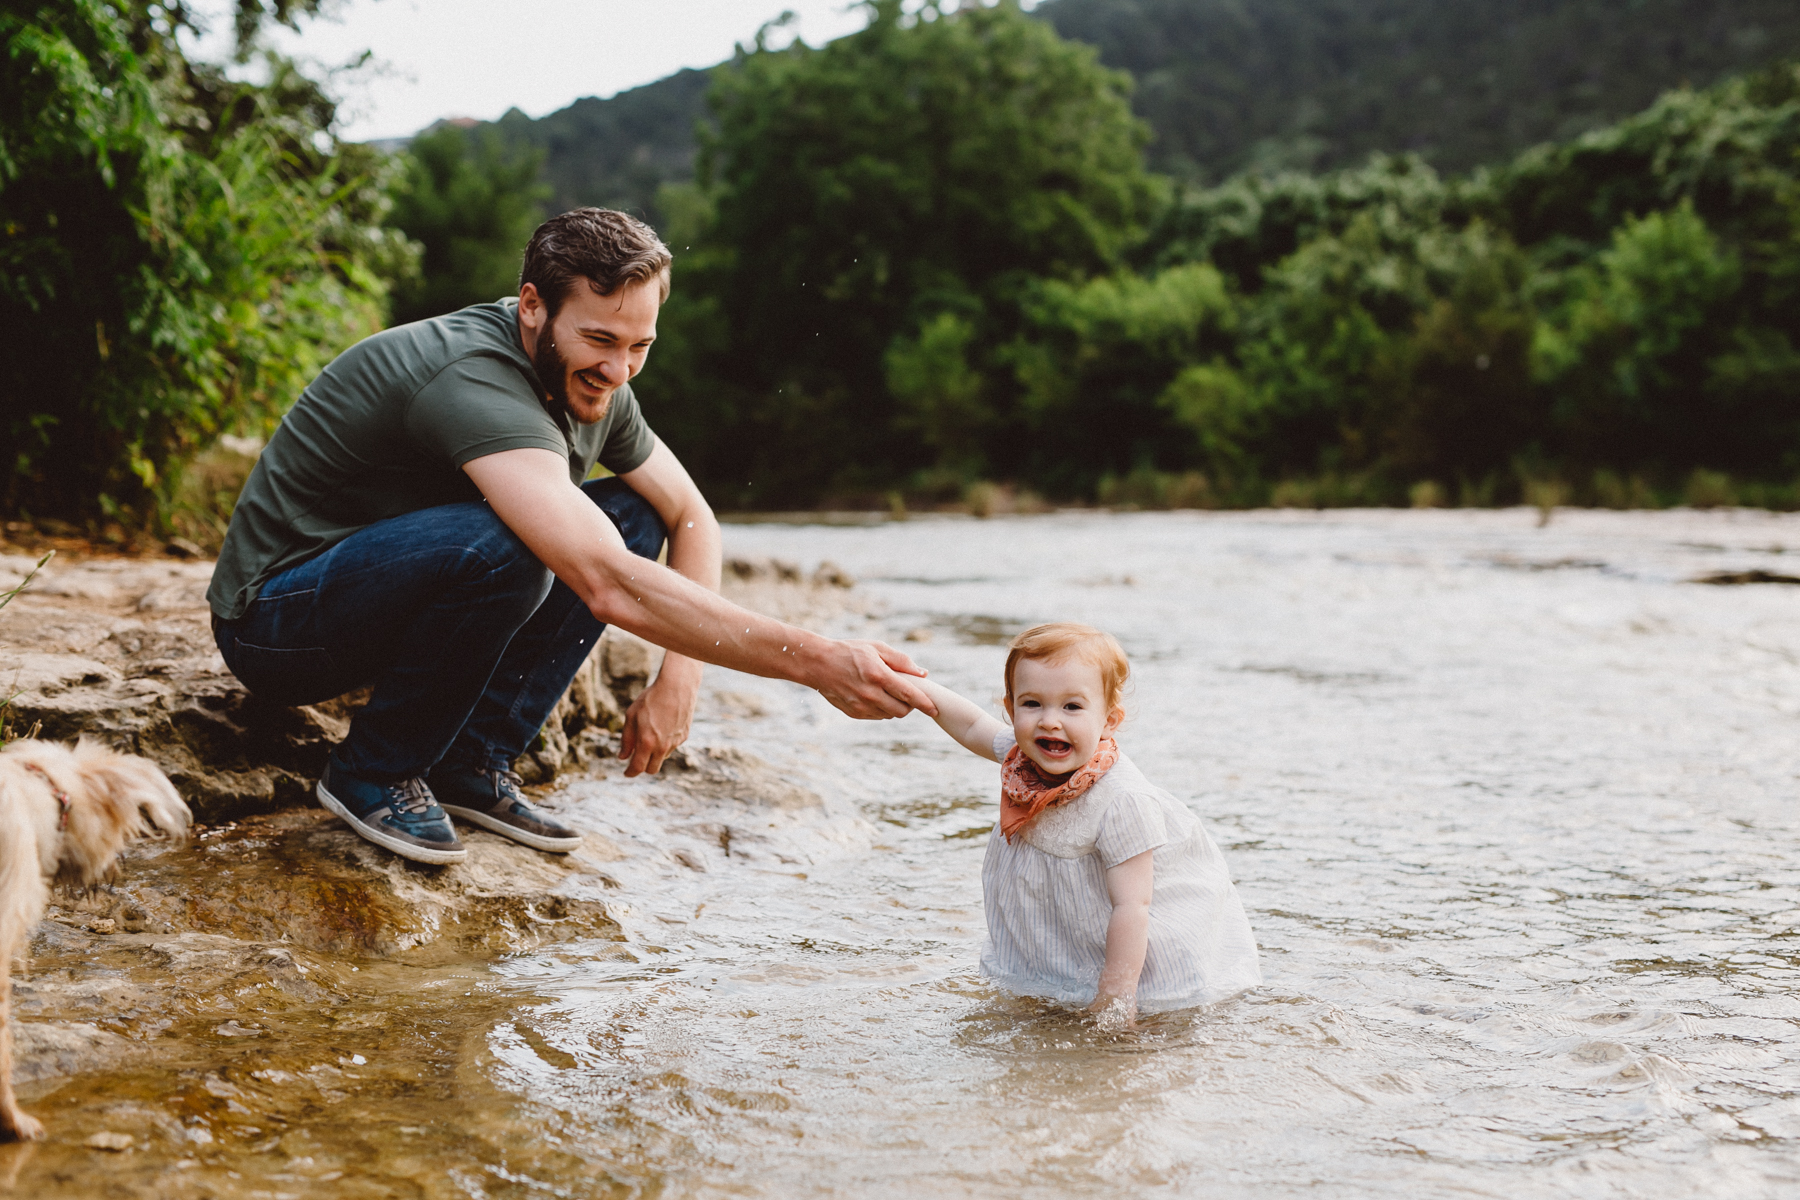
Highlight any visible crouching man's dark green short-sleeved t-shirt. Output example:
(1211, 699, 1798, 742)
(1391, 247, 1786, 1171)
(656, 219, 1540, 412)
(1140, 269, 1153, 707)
(207, 300, 655, 621)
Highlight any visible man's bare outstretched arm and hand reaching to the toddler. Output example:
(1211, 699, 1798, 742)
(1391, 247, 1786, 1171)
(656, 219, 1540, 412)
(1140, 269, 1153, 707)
(463, 448, 936, 720)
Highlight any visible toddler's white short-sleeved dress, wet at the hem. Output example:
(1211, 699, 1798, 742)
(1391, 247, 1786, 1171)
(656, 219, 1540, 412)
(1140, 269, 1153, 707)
(981, 729, 1262, 1013)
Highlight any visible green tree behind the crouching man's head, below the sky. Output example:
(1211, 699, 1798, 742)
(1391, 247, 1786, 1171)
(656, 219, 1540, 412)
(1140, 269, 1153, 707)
(387, 124, 549, 322)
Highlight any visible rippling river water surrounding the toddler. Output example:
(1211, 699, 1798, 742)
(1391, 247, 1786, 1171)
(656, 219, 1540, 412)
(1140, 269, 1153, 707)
(10, 511, 1800, 1198)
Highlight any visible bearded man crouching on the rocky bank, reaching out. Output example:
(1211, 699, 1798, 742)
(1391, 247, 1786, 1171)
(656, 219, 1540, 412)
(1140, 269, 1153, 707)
(207, 209, 934, 864)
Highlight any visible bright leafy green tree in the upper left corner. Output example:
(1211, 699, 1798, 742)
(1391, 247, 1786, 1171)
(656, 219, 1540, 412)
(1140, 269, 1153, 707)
(0, 0, 409, 522)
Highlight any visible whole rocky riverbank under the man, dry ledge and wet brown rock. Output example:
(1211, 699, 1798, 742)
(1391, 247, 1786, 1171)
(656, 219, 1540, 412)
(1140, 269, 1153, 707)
(0, 554, 864, 1196)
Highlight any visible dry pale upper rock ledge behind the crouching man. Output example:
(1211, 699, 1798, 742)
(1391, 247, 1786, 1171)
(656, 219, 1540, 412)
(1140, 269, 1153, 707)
(0, 554, 859, 824)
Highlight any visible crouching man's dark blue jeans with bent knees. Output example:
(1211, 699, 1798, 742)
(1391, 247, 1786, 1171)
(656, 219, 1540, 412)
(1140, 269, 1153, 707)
(214, 479, 668, 783)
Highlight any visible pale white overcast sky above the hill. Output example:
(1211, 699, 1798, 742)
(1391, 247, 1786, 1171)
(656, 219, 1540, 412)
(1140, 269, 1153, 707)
(182, 0, 900, 140)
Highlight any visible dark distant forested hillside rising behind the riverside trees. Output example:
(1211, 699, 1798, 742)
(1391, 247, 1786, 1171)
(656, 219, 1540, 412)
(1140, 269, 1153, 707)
(497, 0, 1800, 221)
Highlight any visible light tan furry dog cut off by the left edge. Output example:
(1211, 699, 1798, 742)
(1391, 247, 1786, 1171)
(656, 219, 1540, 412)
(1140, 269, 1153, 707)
(0, 741, 191, 1141)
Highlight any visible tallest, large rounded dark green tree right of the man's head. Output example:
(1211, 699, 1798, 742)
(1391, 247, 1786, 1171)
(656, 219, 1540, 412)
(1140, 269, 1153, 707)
(668, 0, 1154, 504)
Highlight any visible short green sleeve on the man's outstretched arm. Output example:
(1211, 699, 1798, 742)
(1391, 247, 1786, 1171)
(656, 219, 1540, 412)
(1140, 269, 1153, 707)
(405, 354, 569, 470)
